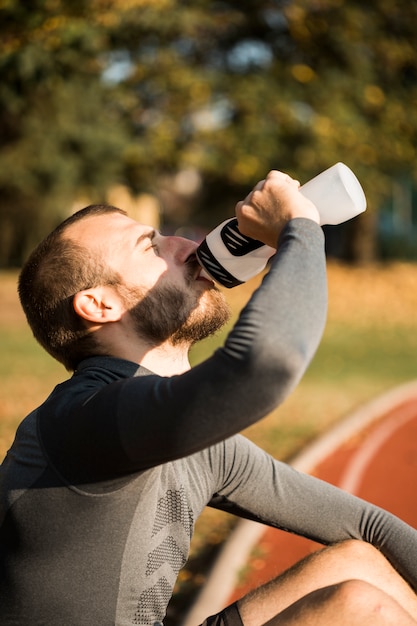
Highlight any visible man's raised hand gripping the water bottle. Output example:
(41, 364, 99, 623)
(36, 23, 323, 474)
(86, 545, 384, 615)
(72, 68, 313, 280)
(236, 170, 320, 248)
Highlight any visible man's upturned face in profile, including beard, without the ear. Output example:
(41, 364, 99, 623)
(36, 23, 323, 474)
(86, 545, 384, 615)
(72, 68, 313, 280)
(68, 213, 230, 345)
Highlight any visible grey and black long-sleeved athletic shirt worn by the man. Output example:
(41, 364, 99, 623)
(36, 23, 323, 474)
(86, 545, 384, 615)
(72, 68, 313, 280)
(0, 219, 417, 626)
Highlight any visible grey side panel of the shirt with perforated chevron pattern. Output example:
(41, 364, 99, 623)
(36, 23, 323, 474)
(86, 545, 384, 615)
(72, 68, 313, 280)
(116, 462, 194, 626)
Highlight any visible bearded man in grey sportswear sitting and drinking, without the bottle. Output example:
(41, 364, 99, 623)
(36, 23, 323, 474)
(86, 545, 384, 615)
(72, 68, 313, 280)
(0, 172, 417, 626)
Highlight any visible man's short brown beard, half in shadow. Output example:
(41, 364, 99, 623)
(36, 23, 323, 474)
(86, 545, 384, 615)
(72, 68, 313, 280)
(120, 285, 230, 346)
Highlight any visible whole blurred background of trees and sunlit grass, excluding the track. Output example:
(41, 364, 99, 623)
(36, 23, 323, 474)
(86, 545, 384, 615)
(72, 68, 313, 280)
(0, 0, 417, 626)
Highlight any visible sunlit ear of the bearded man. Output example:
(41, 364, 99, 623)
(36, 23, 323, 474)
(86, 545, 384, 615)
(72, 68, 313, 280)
(73, 287, 124, 324)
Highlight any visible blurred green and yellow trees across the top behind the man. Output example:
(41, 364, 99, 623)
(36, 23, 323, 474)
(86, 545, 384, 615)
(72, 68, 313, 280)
(0, 0, 417, 262)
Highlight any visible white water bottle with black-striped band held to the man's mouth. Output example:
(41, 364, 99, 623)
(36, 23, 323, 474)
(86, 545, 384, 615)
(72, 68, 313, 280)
(196, 163, 366, 288)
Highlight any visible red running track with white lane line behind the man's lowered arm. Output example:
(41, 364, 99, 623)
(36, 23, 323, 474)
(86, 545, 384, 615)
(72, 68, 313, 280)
(226, 397, 417, 604)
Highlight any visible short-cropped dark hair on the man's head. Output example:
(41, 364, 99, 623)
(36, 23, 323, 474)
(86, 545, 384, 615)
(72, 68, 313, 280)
(18, 204, 126, 371)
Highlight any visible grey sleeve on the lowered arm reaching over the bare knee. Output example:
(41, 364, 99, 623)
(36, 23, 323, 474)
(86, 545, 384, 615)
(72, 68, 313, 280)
(211, 436, 417, 590)
